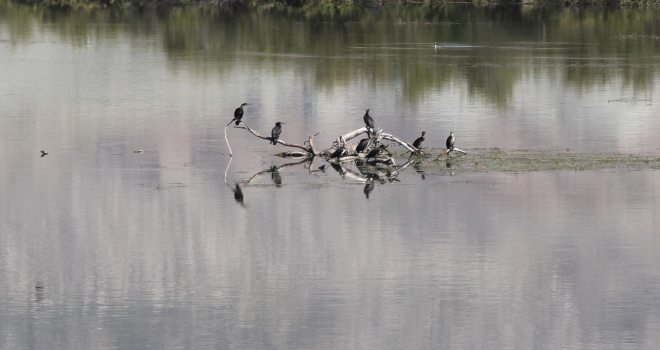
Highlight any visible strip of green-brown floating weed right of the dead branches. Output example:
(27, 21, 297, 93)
(412, 148, 660, 174)
